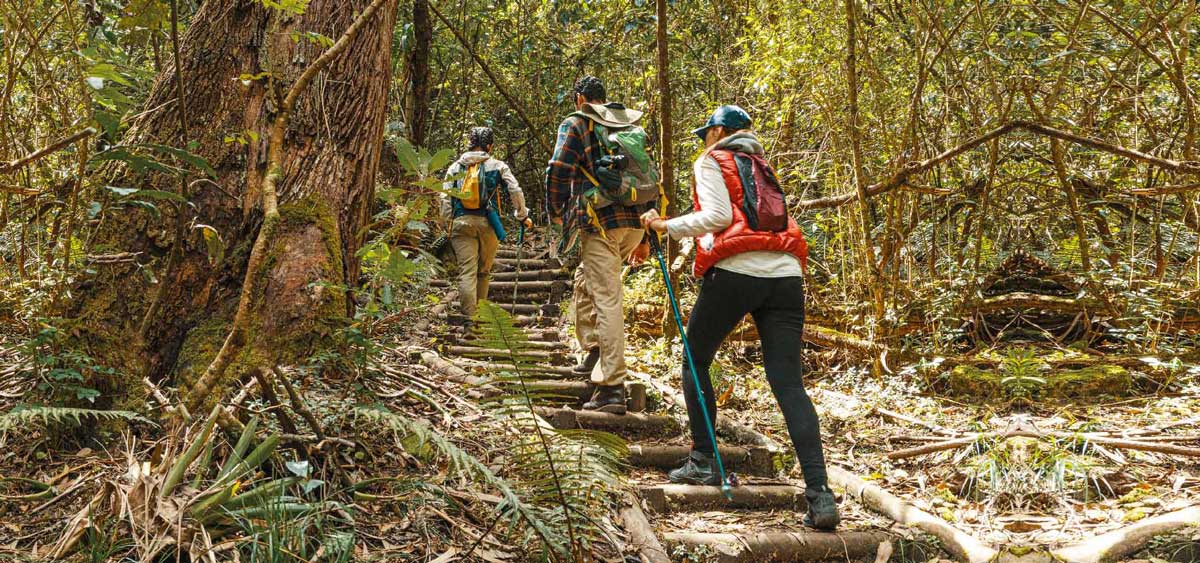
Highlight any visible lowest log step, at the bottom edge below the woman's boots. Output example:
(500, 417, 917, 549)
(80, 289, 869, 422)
(662, 531, 893, 563)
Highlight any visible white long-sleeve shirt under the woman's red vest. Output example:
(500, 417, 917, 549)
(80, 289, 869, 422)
(667, 151, 804, 277)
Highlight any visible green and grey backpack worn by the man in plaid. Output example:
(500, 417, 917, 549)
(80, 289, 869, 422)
(575, 113, 662, 209)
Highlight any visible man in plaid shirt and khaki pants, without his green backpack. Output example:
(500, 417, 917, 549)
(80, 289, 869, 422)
(546, 76, 658, 414)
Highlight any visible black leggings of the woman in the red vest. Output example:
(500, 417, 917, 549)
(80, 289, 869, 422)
(683, 268, 826, 489)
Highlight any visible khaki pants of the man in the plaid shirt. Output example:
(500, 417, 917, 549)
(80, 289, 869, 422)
(574, 228, 646, 385)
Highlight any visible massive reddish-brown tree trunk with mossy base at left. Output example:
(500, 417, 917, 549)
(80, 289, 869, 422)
(68, 0, 395, 403)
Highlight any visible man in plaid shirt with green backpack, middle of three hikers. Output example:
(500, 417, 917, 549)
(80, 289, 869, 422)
(546, 76, 661, 414)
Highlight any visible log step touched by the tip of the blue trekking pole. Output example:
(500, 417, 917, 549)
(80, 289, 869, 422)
(638, 484, 809, 514)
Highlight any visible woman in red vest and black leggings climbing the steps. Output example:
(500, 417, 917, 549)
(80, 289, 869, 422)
(642, 106, 840, 529)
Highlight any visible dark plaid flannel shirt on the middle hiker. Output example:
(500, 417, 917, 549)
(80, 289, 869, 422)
(546, 102, 656, 233)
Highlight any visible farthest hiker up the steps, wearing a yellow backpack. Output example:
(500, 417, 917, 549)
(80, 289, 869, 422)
(442, 127, 533, 322)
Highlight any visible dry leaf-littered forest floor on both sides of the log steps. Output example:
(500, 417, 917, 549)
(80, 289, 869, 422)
(7, 274, 1200, 562)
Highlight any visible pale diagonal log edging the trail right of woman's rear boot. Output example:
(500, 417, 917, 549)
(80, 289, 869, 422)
(828, 466, 996, 563)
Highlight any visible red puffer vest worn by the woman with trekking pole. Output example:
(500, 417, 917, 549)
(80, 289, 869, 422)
(691, 150, 809, 277)
